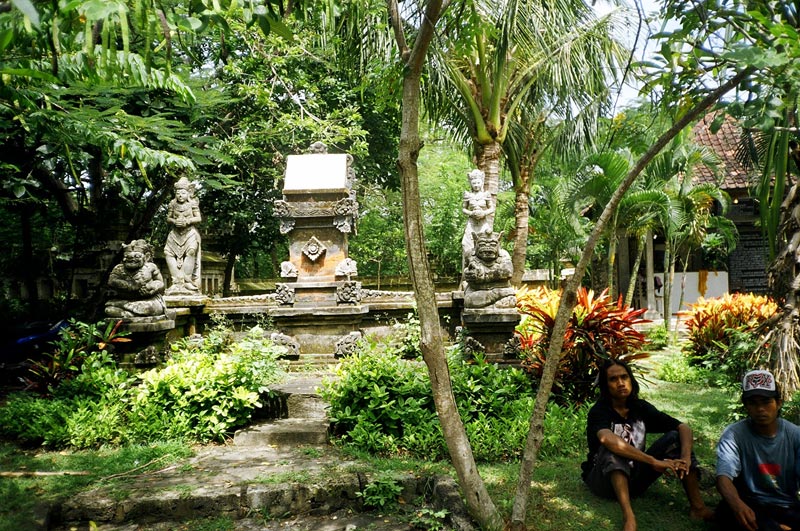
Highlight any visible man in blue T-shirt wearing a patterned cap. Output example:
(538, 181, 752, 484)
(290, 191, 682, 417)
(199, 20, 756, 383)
(717, 370, 800, 531)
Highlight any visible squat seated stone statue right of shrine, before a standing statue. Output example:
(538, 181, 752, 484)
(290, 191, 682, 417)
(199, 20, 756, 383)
(464, 231, 517, 308)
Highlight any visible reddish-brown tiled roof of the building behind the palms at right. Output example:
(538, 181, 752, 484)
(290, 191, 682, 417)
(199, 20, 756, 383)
(693, 113, 752, 195)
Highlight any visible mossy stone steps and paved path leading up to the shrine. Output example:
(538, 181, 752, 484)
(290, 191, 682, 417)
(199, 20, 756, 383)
(45, 376, 474, 531)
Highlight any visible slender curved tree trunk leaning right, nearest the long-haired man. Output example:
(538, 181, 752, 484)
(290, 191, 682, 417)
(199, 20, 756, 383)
(510, 68, 752, 531)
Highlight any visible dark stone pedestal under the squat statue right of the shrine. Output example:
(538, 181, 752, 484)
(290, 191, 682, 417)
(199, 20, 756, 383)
(461, 308, 520, 362)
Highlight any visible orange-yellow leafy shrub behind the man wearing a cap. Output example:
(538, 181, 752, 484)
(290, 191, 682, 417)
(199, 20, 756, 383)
(685, 293, 778, 384)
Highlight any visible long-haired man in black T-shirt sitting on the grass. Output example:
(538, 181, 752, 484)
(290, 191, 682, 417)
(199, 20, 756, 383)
(581, 360, 713, 531)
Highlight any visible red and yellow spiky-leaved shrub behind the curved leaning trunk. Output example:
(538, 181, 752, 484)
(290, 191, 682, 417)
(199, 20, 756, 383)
(517, 287, 649, 404)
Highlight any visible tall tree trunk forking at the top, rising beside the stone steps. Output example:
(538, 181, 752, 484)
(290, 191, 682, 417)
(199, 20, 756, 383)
(388, 0, 503, 530)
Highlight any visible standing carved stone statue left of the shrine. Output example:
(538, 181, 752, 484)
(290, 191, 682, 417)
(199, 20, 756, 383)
(164, 177, 201, 295)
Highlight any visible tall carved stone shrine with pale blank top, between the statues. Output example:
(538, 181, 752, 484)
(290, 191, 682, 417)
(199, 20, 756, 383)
(270, 143, 368, 364)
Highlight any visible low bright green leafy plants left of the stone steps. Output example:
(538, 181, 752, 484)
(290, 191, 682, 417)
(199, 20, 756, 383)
(0, 326, 283, 448)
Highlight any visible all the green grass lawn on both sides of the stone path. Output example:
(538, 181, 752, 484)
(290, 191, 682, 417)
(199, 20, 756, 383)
(0, 352, 735, 531)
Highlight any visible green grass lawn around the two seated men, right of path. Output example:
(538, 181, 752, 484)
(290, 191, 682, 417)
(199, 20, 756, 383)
(481, 351, 736, 531)
